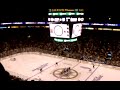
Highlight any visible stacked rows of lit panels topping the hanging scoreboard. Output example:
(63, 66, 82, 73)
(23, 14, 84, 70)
(48, 9, 84, 22)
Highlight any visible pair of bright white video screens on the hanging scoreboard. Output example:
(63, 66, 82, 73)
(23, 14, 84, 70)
(49, 23, 82, 38)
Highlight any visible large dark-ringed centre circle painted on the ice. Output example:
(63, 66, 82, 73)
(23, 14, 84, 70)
(53, 68, 78, 79)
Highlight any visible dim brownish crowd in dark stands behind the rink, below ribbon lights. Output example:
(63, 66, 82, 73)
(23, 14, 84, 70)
(0, 29, 120, 80)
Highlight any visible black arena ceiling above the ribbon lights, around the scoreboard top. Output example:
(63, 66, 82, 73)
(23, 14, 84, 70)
(0, 0, 120, 22)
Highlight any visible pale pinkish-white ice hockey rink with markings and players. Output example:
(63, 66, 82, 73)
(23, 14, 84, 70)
(0, 52, 120, 81)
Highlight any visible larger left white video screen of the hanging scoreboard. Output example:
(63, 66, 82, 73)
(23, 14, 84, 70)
(49, 24, 70, 38)
